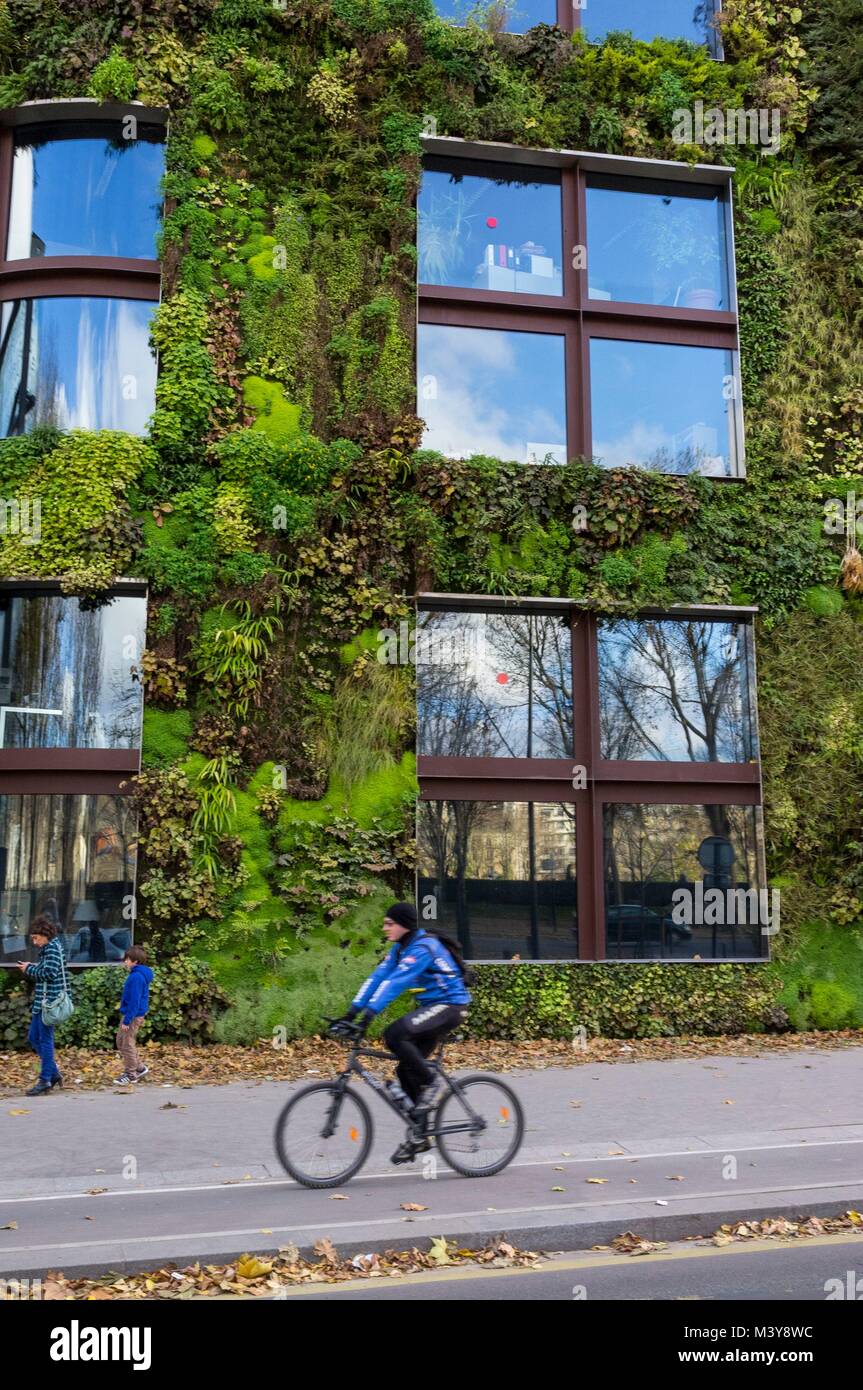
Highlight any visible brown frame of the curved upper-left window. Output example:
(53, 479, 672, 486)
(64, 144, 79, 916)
(0, 99, 168, 347)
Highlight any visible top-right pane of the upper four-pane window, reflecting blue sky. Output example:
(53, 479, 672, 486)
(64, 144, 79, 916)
(586, 175, 728, 309)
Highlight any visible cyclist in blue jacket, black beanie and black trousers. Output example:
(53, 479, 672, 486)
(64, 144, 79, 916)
(331, 902, 471, 1163)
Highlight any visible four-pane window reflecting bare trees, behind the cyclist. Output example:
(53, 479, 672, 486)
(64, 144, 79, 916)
(416, 595, 773, 959)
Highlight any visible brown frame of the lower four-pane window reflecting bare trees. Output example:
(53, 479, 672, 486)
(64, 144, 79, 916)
(417, 594, 769, 963)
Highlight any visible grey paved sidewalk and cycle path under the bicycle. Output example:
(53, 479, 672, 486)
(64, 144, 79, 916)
(0, 1048, 863, 1276)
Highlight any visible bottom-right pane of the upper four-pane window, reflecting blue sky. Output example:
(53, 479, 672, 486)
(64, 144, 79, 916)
(591, 338, 738, 477)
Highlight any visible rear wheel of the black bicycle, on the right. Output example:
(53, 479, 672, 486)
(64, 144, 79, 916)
(432, 1074, 524, 1177)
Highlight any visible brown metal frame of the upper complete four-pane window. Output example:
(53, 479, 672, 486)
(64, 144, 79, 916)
(417, 136, 746, 472)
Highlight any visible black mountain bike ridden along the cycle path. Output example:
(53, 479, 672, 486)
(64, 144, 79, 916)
(275, 1019, 524, 1187)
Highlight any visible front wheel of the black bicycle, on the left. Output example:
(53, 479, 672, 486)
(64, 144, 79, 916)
(275, 1081, 374, 1187)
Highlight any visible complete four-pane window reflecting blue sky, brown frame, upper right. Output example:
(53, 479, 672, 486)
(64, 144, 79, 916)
(417, 139, 743, 478)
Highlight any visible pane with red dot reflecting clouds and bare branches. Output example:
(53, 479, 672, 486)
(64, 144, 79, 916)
(417, 612, 573, 758)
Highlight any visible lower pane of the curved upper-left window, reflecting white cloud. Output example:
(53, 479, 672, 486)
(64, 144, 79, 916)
(0, 297, 156, 435)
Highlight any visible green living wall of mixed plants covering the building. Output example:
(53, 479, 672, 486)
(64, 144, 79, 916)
(0, 0, 863, 1038)
